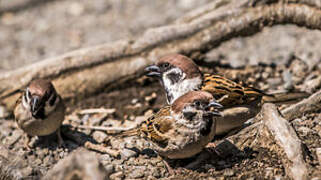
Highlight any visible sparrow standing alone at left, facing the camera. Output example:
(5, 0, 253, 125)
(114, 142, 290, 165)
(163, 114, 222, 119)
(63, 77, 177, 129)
(14, 79, 65, 148)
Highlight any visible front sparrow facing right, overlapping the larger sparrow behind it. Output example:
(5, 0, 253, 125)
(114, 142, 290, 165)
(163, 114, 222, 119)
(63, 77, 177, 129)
(120, 91, 222, 159)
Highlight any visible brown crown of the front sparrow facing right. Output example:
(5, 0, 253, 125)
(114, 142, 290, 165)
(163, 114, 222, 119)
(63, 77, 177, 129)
(172, 91, 213, 113)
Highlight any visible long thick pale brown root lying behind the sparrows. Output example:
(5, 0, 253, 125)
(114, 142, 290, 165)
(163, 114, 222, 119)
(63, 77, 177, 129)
(0, 0, 321, 110)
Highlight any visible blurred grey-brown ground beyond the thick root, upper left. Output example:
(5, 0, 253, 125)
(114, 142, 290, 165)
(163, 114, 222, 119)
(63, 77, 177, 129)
(0, 0, 210, 71)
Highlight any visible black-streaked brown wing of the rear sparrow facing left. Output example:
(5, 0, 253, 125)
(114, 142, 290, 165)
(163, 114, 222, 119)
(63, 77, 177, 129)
(202, 74, 265, 107)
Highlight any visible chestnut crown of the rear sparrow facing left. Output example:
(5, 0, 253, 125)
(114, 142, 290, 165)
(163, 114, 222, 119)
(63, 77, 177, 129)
(157, 54, 201, 78)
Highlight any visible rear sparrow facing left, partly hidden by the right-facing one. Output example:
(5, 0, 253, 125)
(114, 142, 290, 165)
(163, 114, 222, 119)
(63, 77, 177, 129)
(145, 54, 307, 134)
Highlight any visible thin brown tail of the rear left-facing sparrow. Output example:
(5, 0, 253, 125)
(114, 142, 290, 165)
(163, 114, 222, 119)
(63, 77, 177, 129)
(262, 92, 310, 103)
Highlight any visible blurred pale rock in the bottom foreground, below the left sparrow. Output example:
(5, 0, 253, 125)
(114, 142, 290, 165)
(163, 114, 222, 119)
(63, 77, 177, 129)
(43, 148, 109, 180)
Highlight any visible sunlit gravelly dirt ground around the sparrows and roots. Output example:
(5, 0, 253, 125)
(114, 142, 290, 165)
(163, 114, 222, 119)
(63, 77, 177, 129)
(0, 0, 321, 180)
